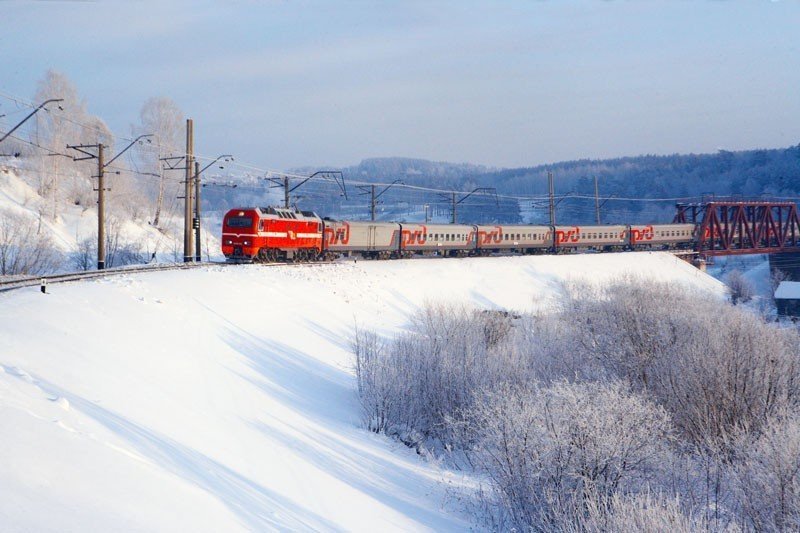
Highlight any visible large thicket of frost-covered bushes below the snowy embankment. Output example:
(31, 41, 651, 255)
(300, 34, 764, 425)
(353, 280, 800, 532)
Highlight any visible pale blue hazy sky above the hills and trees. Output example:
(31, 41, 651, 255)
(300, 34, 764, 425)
(0, 0, 800, 169)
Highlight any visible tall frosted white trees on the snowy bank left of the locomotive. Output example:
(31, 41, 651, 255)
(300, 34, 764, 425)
(0, 70, 197, 275)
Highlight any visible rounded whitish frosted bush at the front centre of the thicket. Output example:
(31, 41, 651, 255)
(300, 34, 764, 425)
(455, 383, 671, 531)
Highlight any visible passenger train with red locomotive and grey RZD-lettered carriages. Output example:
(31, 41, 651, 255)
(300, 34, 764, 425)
(222, 207, 698, 262)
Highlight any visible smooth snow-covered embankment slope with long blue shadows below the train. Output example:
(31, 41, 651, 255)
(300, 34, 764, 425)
(0, 253, 722, 531)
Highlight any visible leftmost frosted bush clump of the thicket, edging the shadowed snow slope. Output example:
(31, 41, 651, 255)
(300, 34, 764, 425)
(353, 306, 531, 443)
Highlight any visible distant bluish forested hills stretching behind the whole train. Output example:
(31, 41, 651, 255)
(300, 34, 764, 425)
(205, 145, 800, 224)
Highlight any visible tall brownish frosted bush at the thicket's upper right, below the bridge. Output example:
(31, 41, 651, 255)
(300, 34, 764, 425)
(564, 283, 800, 449)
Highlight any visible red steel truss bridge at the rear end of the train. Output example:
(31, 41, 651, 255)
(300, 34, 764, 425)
(674, 200, 800, 256)
